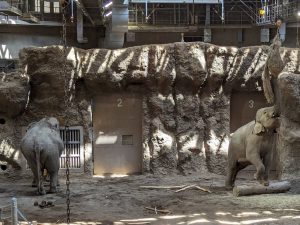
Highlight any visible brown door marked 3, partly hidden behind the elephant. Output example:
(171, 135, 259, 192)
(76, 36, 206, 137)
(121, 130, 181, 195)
(230, 92, 268, 133)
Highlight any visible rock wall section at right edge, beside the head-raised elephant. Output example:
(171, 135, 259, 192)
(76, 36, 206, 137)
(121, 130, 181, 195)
(278, 72, 300, 178)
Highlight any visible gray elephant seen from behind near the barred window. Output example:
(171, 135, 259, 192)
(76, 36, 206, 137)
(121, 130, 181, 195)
(21, 117, 64, 195)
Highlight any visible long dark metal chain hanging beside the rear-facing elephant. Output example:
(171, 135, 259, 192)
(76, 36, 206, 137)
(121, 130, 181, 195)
(62, 7, 71, 224)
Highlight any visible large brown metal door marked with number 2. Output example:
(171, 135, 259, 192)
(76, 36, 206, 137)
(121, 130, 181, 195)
(93, 93, 142, 175)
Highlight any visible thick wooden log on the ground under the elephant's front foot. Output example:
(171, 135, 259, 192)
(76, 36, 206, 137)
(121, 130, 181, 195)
(233, 181, 291, 197)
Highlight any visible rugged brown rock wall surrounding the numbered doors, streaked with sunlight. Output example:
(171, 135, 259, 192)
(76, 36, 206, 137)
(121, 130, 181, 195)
(0, 43, 300, 175)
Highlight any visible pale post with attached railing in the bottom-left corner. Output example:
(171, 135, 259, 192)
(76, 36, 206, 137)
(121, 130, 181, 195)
(0, 198, 36, 225)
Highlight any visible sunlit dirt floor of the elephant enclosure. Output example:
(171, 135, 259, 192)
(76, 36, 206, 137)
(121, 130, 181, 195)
(0, 174, 300, 225)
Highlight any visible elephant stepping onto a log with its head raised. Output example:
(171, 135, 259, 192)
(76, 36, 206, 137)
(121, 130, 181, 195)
(225, 106, 280, 189)
